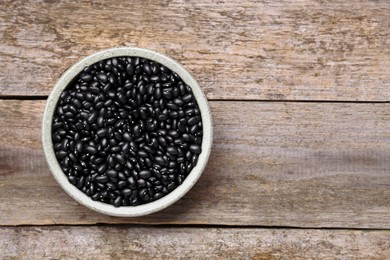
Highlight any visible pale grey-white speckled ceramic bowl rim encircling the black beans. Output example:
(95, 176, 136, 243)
(42, 47, 213, 217)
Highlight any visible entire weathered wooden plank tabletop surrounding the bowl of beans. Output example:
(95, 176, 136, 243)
(0, 0, 390, 259)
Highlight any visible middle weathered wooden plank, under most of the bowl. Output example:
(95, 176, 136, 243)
(0, 100, 390, 228)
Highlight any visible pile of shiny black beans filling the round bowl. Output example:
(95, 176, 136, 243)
(52, 57, 203, 207)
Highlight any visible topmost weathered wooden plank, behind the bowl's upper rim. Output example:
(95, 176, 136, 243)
(0, 0, 390, 101)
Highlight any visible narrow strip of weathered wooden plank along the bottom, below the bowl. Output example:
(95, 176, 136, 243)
(0, 226, 390, 260)
